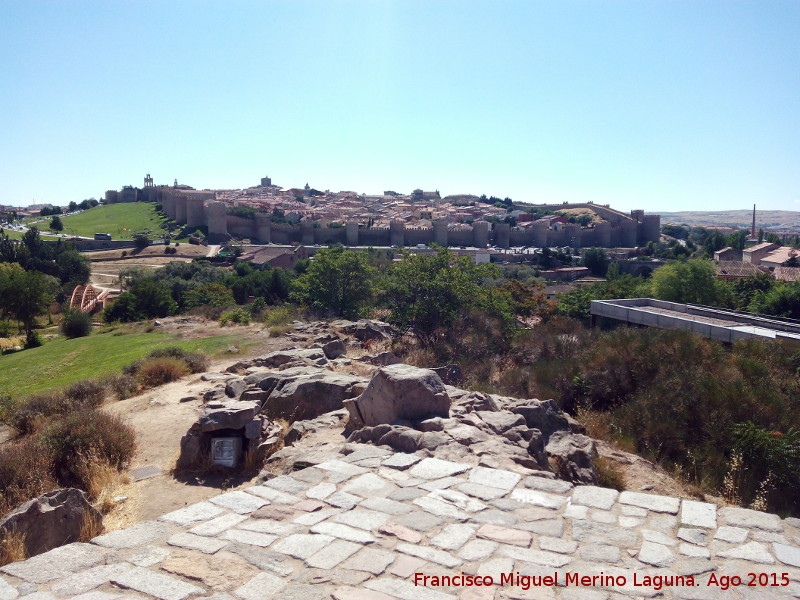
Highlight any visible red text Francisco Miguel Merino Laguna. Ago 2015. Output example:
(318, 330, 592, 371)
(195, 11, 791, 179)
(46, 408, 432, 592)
(414, 571, 789, 590)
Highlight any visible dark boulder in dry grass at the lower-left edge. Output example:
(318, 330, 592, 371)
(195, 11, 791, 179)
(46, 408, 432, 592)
(0, 488, 103, 556)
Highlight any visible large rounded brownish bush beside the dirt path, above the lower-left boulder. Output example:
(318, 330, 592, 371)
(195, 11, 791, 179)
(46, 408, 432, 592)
(40, 410, 136, 489)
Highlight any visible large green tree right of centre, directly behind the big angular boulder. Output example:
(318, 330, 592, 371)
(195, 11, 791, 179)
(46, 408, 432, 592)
(385, 248, 497, 345)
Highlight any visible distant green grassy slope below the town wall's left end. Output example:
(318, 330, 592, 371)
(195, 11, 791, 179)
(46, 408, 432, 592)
(56, 202, 166, 240)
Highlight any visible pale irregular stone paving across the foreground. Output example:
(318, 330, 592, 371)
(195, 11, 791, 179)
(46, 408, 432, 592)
(0, 445, 800, 600)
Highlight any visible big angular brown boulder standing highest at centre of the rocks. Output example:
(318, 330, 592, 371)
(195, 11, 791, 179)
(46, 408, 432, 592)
(347, 364, 450, 425)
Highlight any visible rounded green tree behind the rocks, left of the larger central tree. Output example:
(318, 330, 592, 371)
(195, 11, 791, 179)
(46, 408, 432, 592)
(290, 246, 377, 318)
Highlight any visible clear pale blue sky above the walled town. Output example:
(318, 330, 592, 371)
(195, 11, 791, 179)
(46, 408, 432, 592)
(0, 0, 800, 212)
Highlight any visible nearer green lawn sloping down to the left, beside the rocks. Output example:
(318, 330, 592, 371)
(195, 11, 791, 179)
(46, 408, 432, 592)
(0, 332, 242, 398)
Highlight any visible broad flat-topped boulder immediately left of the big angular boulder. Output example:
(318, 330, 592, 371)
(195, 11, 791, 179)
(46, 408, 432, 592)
(261, 371, 363, 422)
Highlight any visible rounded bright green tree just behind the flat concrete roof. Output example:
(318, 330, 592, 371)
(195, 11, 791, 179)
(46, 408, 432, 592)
(650, 259, 722, 304)
